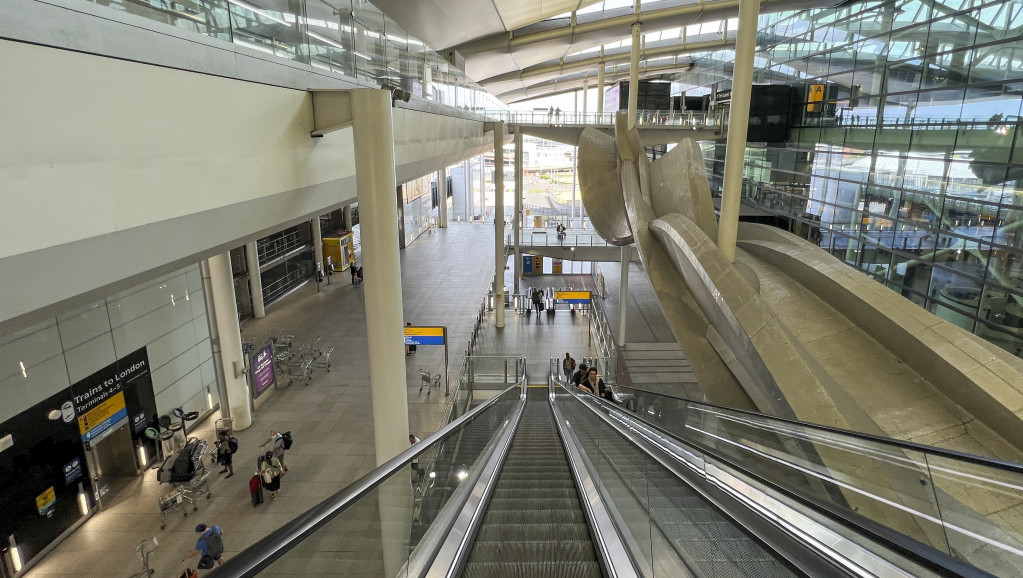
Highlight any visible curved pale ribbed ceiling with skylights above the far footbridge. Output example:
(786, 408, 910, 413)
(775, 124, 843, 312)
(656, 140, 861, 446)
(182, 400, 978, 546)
(373, 0, 842, 102)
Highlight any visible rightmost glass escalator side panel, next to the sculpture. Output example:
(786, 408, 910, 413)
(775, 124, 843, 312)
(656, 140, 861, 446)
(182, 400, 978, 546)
(615, 386, 1023, 576)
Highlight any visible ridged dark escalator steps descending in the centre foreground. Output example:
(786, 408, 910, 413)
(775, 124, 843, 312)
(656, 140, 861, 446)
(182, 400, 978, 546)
(461, 388, 603, 578)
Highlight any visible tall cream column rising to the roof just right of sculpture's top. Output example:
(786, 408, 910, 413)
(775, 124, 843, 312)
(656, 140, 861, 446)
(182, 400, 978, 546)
(717, 0, 760, 263)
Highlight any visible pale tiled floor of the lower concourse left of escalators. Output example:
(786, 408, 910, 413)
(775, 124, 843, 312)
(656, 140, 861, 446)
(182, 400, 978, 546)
(26, 224, 658, 578)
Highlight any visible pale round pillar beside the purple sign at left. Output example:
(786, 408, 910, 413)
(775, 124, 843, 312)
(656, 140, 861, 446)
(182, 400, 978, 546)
(199, 253, 252, 431)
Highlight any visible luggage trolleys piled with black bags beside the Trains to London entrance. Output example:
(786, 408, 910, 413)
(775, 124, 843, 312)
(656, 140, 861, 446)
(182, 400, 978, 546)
(157, 438, 213, 530)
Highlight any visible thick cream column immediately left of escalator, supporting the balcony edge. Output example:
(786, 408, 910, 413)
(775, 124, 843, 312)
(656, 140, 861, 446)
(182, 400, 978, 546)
(352, 89, 408, 465)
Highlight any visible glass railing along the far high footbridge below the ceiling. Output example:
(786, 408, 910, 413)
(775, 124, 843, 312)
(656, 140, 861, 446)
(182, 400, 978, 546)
(483, 109, 723, 129)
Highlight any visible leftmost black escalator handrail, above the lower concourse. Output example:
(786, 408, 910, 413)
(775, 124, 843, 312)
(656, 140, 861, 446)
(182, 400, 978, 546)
(210, 380, 525, 578)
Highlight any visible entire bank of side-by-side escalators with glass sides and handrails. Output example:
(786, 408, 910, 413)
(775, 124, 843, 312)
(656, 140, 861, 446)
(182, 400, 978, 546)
(207, 359, 1023, 577)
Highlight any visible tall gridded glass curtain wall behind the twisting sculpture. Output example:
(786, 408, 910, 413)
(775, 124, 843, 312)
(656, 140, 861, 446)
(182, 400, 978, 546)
(681, 0, 1023, 356)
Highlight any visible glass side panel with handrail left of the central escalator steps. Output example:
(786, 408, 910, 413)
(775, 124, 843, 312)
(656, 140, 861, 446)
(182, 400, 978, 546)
(216, 381, 525, 578)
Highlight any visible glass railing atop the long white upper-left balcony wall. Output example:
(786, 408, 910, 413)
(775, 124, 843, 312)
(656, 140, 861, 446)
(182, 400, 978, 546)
(81, 0, 506, 112)
